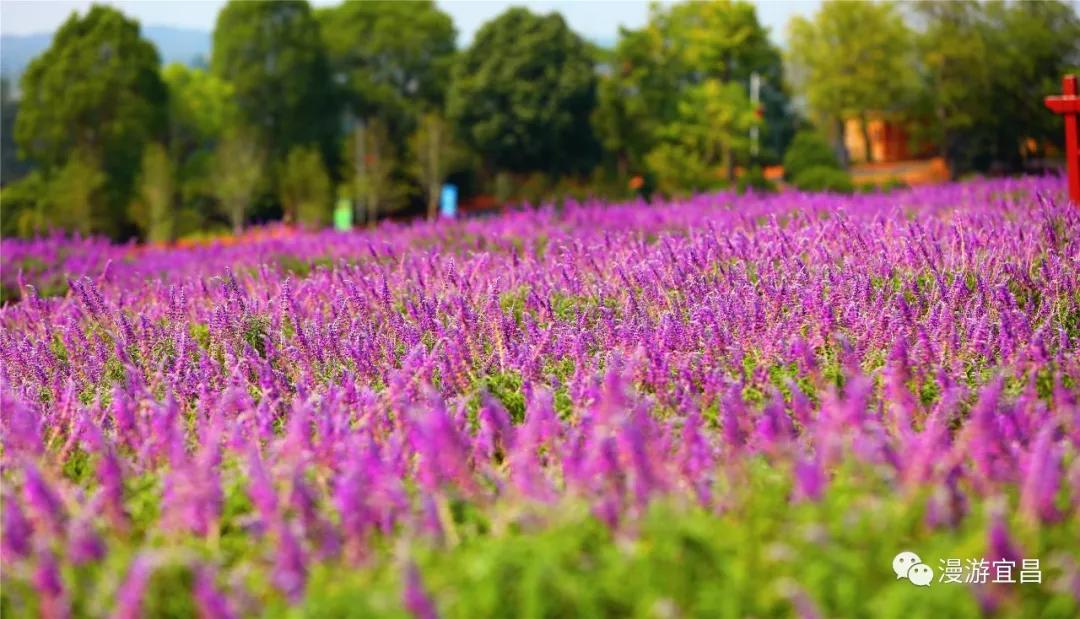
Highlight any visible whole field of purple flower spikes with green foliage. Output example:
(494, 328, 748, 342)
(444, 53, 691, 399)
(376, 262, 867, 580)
(0, 178, 1080, 618)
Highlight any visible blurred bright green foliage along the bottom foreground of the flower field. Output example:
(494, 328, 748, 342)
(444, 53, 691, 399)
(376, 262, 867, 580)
(293, 460, 1078, 619)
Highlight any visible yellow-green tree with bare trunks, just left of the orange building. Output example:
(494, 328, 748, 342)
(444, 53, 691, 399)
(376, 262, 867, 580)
(787, 0, 914, 162)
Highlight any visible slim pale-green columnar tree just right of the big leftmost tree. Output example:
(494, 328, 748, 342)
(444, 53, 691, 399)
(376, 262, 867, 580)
(131, 144, 176, 243)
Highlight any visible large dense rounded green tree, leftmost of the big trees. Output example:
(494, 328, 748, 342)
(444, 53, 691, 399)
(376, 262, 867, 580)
(15, 5, 166, 234)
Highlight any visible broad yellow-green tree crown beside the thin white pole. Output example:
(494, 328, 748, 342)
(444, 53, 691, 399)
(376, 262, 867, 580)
(593, 1, 793, 186)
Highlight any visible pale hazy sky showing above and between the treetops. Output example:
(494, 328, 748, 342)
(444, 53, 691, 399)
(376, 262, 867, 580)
(0, 0, 820, 42)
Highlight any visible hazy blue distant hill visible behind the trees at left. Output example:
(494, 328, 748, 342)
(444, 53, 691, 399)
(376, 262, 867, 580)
(0, 26, 211, 84)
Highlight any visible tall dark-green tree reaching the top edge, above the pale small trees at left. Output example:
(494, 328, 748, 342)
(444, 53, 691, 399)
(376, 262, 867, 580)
(211, 0, 338, 162)
